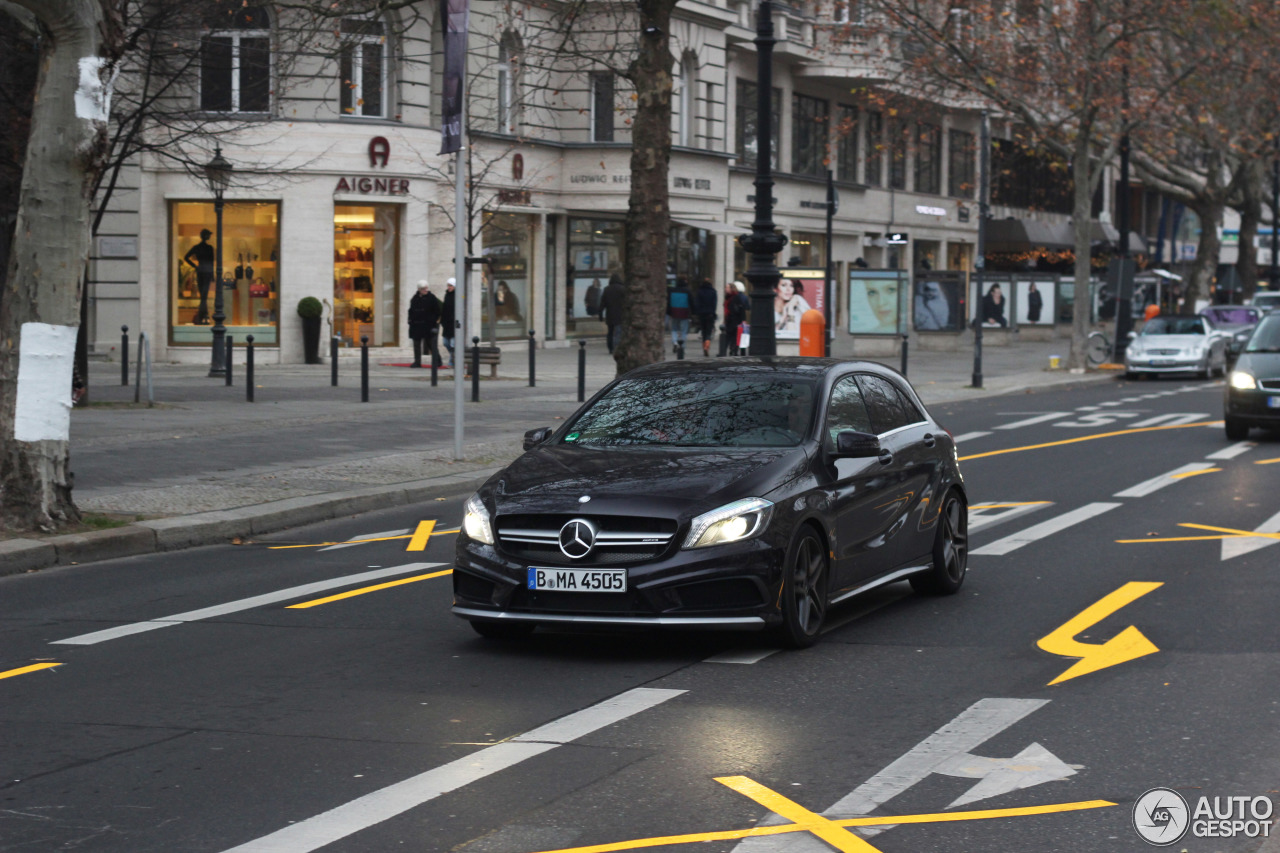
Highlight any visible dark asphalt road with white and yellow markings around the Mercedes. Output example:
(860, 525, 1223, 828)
(0, 379, 1280, 853)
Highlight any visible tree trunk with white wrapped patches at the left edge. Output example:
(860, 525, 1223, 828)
(0, 0, 119, 530)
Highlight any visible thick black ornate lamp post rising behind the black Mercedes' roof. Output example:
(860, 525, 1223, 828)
(737, 0, 783, 356)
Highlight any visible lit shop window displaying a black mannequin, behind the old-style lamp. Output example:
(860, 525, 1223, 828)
(169, 201, 280, 346)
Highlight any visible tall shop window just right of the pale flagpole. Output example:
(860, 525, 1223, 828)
(480, 213, 538, 341)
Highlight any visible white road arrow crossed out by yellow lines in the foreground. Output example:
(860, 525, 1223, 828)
(733, 699, 1076, 853)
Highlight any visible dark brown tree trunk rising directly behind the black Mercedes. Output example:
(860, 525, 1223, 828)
(613, 0, 676, 375)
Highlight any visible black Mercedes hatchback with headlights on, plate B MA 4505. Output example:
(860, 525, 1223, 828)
(453, 357, 969, 647)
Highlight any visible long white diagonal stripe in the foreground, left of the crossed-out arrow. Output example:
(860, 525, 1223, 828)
(225, 688, 685, 853)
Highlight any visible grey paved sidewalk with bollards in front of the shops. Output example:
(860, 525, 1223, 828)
(0, 341, 1108, 574)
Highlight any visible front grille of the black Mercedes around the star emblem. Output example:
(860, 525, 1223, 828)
(498, 515, 676, 566)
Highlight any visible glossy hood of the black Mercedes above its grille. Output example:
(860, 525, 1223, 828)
(489, 444, 808, 516)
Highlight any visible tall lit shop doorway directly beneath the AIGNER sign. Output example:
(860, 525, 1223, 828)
(333, 205, 399, 347)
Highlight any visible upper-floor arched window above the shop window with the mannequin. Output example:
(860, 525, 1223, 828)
(200, 6, 271, 113)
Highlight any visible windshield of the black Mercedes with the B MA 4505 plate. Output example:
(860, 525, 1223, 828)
(561, 374, 814, 447)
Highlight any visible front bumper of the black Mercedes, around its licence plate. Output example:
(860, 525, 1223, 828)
(452, 538, 786, 630)
